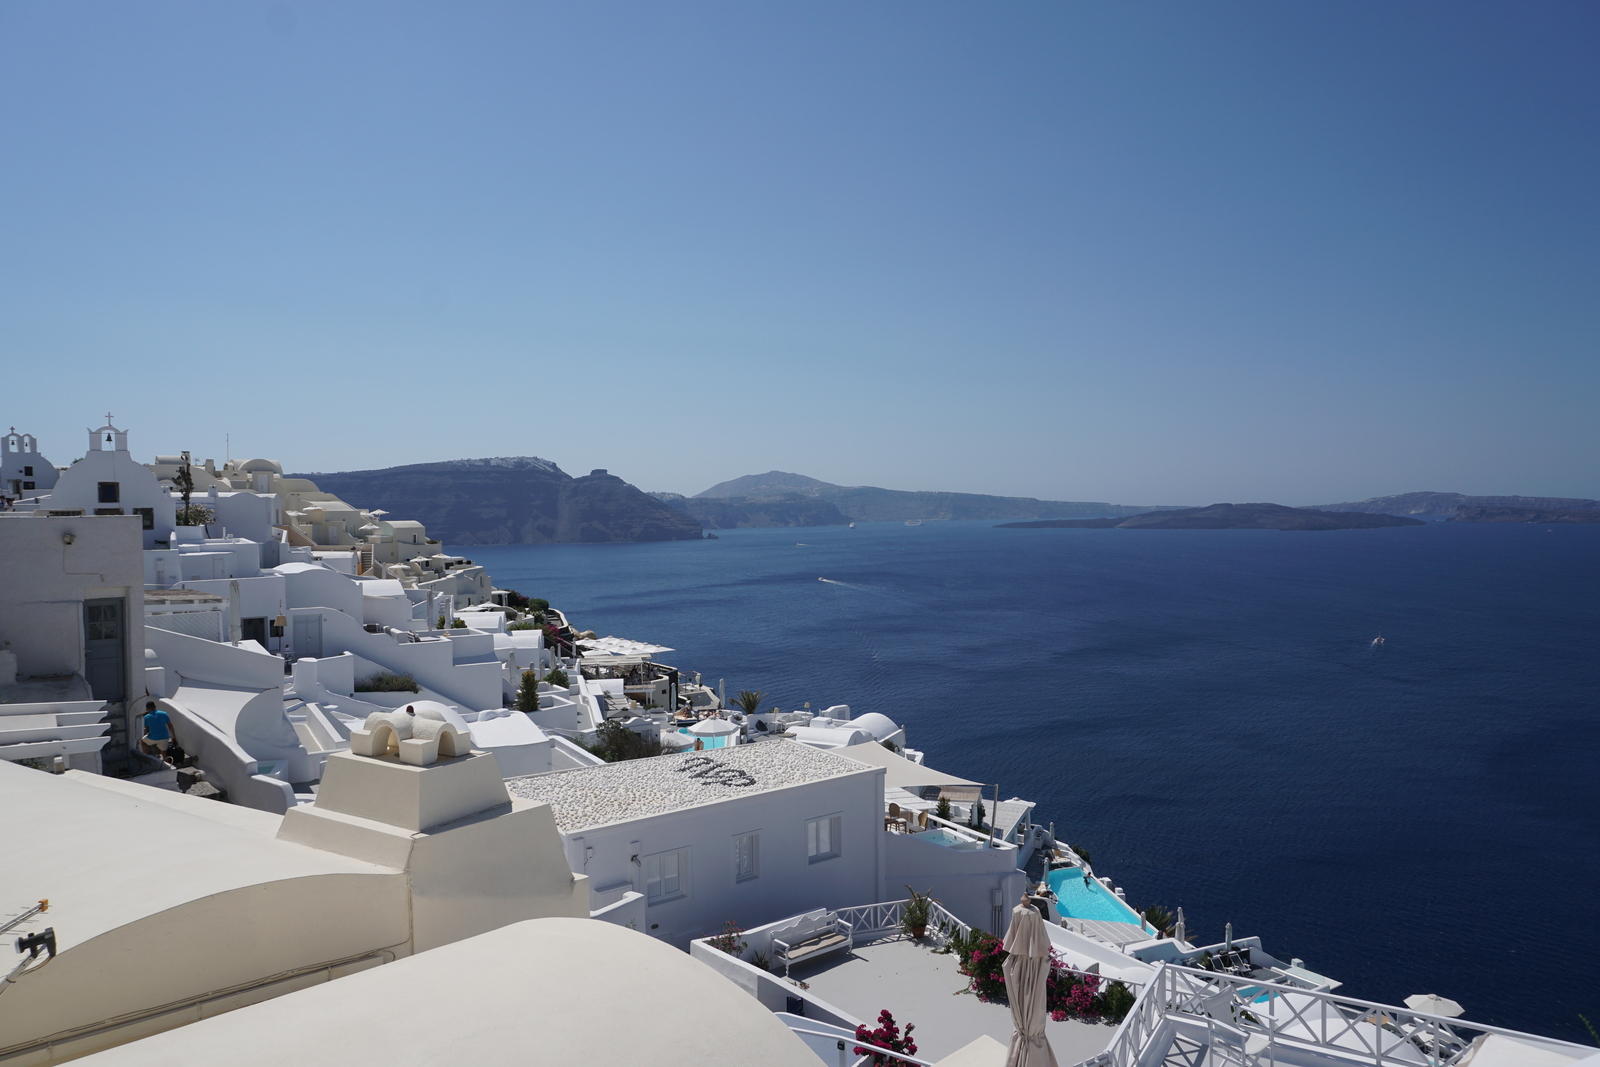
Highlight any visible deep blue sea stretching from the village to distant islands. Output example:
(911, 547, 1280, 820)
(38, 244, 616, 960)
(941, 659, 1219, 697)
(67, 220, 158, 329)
(458, 523, 1600, 1041)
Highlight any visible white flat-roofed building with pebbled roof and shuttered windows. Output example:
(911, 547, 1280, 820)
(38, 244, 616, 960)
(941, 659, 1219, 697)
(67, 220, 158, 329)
(507, 744, 885, 947)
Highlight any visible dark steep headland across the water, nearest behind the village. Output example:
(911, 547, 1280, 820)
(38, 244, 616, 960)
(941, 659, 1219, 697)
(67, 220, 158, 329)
(294, 456, 702, 545)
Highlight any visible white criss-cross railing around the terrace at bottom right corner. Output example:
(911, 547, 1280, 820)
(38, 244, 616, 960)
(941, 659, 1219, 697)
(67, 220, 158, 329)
(1078, 965, 1592, 1067)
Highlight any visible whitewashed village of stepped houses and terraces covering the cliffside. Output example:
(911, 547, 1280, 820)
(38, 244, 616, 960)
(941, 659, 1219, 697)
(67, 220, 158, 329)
(0, 416, 1600, 1067)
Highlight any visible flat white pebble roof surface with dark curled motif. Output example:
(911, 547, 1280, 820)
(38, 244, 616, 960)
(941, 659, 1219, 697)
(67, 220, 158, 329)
(506, 741, 878, 833)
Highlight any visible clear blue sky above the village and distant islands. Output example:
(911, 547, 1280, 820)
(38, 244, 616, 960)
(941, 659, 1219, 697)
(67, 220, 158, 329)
(0, 0, 1600, 504)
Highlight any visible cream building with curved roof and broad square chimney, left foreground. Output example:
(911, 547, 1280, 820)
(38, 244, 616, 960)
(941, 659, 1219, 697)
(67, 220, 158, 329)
(0, 739, 589, 1064)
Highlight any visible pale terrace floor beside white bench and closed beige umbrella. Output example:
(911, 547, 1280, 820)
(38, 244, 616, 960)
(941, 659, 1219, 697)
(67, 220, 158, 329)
(790, 936, 1115, 1067)
